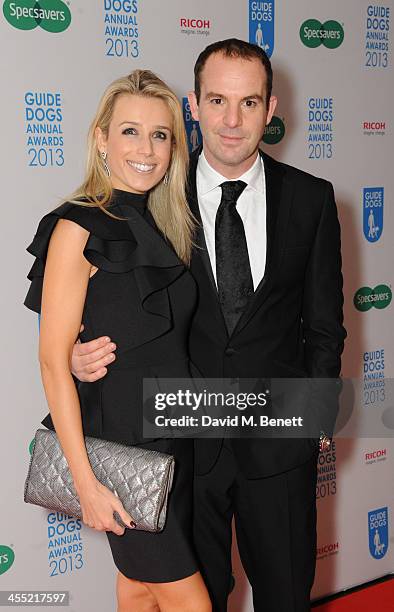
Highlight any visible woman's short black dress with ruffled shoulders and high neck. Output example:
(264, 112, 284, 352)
(25, 190, 198, 582)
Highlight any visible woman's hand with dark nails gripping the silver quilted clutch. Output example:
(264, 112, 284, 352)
(77, 479, 135, 535)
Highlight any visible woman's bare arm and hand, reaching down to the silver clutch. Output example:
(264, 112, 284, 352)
(39, 219, 132, 534)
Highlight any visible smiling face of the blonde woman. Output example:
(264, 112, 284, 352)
(96, 94, 172, 193)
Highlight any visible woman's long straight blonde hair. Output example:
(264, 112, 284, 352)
(69, 70, 195, 264)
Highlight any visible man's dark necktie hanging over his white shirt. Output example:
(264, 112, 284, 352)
(215, 181, 253, 336)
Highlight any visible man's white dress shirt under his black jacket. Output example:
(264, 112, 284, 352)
(196, 151, 267, 289)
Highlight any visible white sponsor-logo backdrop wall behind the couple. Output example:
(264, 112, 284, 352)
(0, 0, 394, 612)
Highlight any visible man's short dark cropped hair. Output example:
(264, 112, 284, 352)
(194, 38, 273, 107)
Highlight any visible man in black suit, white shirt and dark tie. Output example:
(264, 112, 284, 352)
(73, 39, 345, 612)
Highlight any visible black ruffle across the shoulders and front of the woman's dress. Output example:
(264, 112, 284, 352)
(24, 203, 185, 346)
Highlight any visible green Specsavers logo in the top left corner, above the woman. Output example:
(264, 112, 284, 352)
(3, 0, 71, 33)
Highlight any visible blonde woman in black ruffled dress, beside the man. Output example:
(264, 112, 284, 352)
(25, 70, 211, 612)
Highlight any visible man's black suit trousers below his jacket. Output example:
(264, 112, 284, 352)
(194, 440, 317, 612)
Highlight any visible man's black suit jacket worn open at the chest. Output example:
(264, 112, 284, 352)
(188, 150, 346, 478)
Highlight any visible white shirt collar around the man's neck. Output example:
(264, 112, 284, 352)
(197, 150, 265, 196)
